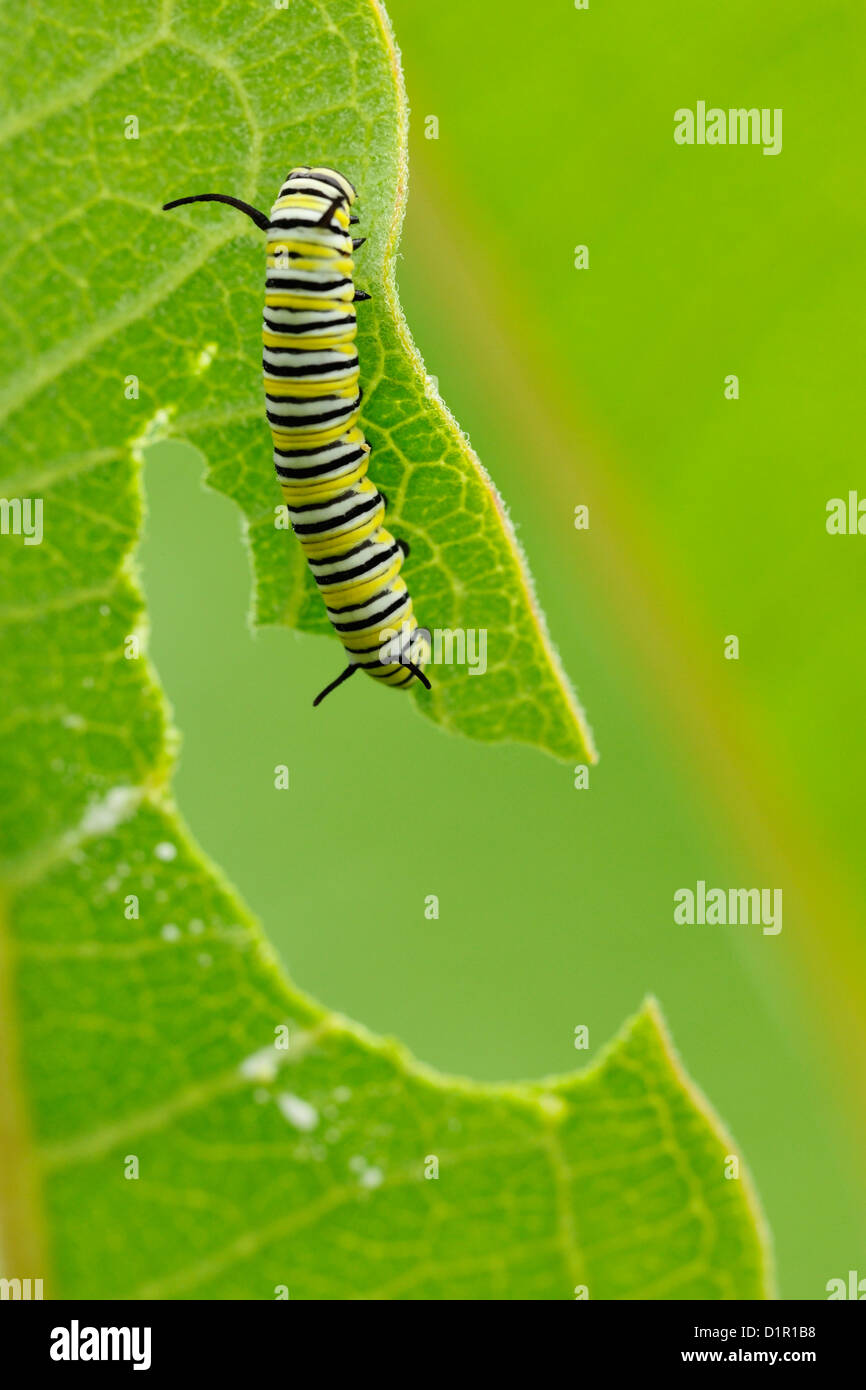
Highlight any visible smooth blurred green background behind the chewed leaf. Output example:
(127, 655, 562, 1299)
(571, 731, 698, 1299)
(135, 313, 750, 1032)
(140, 0, 866, 1298)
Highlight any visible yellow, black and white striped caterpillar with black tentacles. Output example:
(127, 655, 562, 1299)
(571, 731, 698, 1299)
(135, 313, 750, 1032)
(163, 165, 430, 705)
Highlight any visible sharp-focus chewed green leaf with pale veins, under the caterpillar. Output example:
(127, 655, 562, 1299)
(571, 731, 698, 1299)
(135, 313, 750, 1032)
(0, 0, 770, 1298)
